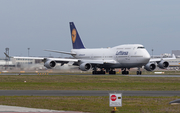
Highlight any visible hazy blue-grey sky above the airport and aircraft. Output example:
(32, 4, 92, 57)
(0, 0, 180, 57)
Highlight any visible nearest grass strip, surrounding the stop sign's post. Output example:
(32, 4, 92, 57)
(0, 96, 180, 113)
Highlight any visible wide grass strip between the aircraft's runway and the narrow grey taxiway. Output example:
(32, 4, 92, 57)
(0, 75, 180, 91)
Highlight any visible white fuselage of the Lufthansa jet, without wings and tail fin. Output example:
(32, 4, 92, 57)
(71, 44, 150, 68)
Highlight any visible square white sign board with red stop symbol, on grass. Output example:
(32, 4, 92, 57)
(109, 93, 122, 107)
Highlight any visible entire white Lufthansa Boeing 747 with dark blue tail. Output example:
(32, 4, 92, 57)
(4, 22, 175, 75)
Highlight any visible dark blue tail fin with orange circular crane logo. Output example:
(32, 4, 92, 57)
(69, 22, 85, 49)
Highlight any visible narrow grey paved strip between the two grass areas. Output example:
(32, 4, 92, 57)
(0, 90, 180, 96)
